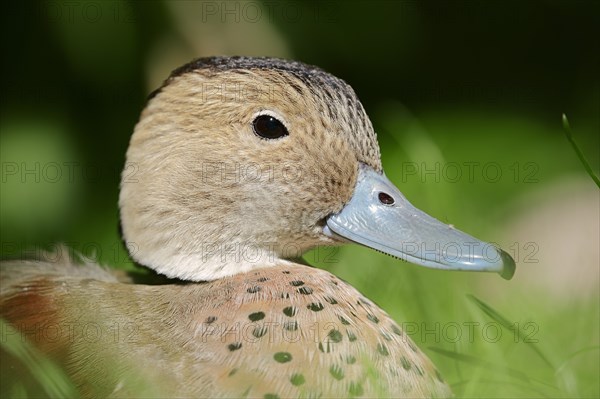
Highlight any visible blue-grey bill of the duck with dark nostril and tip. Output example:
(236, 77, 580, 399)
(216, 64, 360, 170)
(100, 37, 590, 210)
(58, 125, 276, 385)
(324, 164, 515, 280)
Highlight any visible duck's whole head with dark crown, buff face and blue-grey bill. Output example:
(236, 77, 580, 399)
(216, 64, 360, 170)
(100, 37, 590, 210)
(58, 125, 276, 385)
(119, 57, 515, 281)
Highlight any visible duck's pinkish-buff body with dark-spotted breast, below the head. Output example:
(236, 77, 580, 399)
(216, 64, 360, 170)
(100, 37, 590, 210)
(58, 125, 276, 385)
(2, 255, 450, 398)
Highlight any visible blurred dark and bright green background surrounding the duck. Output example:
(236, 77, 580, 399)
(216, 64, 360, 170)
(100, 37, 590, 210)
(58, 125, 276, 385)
(0, 0, 600, 397)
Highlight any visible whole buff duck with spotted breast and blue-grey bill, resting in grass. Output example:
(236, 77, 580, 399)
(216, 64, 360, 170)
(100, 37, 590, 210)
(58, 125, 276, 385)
(0, 56, 515, 399)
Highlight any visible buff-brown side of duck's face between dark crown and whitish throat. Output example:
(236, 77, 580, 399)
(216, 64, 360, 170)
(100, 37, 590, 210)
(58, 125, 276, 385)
(121, 66, 370, 279)
